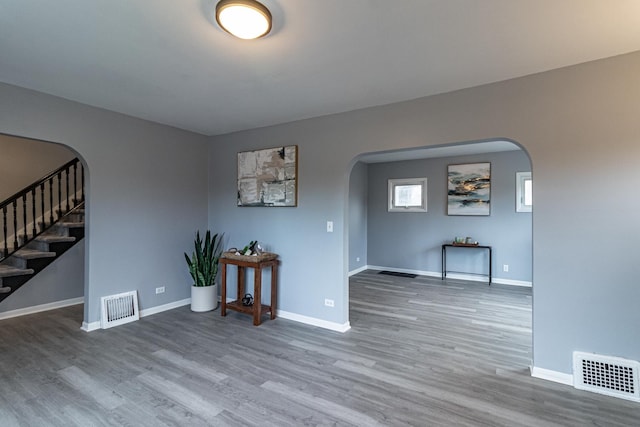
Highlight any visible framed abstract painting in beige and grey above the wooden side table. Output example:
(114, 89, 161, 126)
(238, 145, 298, 207)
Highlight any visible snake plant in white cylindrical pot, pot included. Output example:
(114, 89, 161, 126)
(184, 230, 223, 312)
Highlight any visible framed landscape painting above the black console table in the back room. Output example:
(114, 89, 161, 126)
(447, 163, 491, 215)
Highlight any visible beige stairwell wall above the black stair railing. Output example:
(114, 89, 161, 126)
(0, 134, 76, 201)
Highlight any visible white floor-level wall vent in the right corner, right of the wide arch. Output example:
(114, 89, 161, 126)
(573, 351, 640, 402)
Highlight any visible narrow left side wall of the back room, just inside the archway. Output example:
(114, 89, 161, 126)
(349, 162, 369, 271)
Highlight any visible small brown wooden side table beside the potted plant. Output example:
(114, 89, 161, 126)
(220, 252, 279, 326)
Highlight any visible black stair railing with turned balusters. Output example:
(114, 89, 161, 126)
(0, 158, 84, 261)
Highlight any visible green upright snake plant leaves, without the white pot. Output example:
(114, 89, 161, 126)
(184, 230, 223, 286)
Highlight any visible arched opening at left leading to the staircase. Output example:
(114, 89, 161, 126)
(0, 134, 88, 321)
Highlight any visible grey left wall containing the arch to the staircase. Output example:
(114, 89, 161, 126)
(0, 84, 207, 322)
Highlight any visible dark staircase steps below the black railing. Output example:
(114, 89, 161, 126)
(0, 207, 84, 301)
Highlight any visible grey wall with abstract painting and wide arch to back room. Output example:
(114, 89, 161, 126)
(209, 53, 640, 373)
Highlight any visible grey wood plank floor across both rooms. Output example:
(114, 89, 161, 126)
(0, 271, 640, 427)
